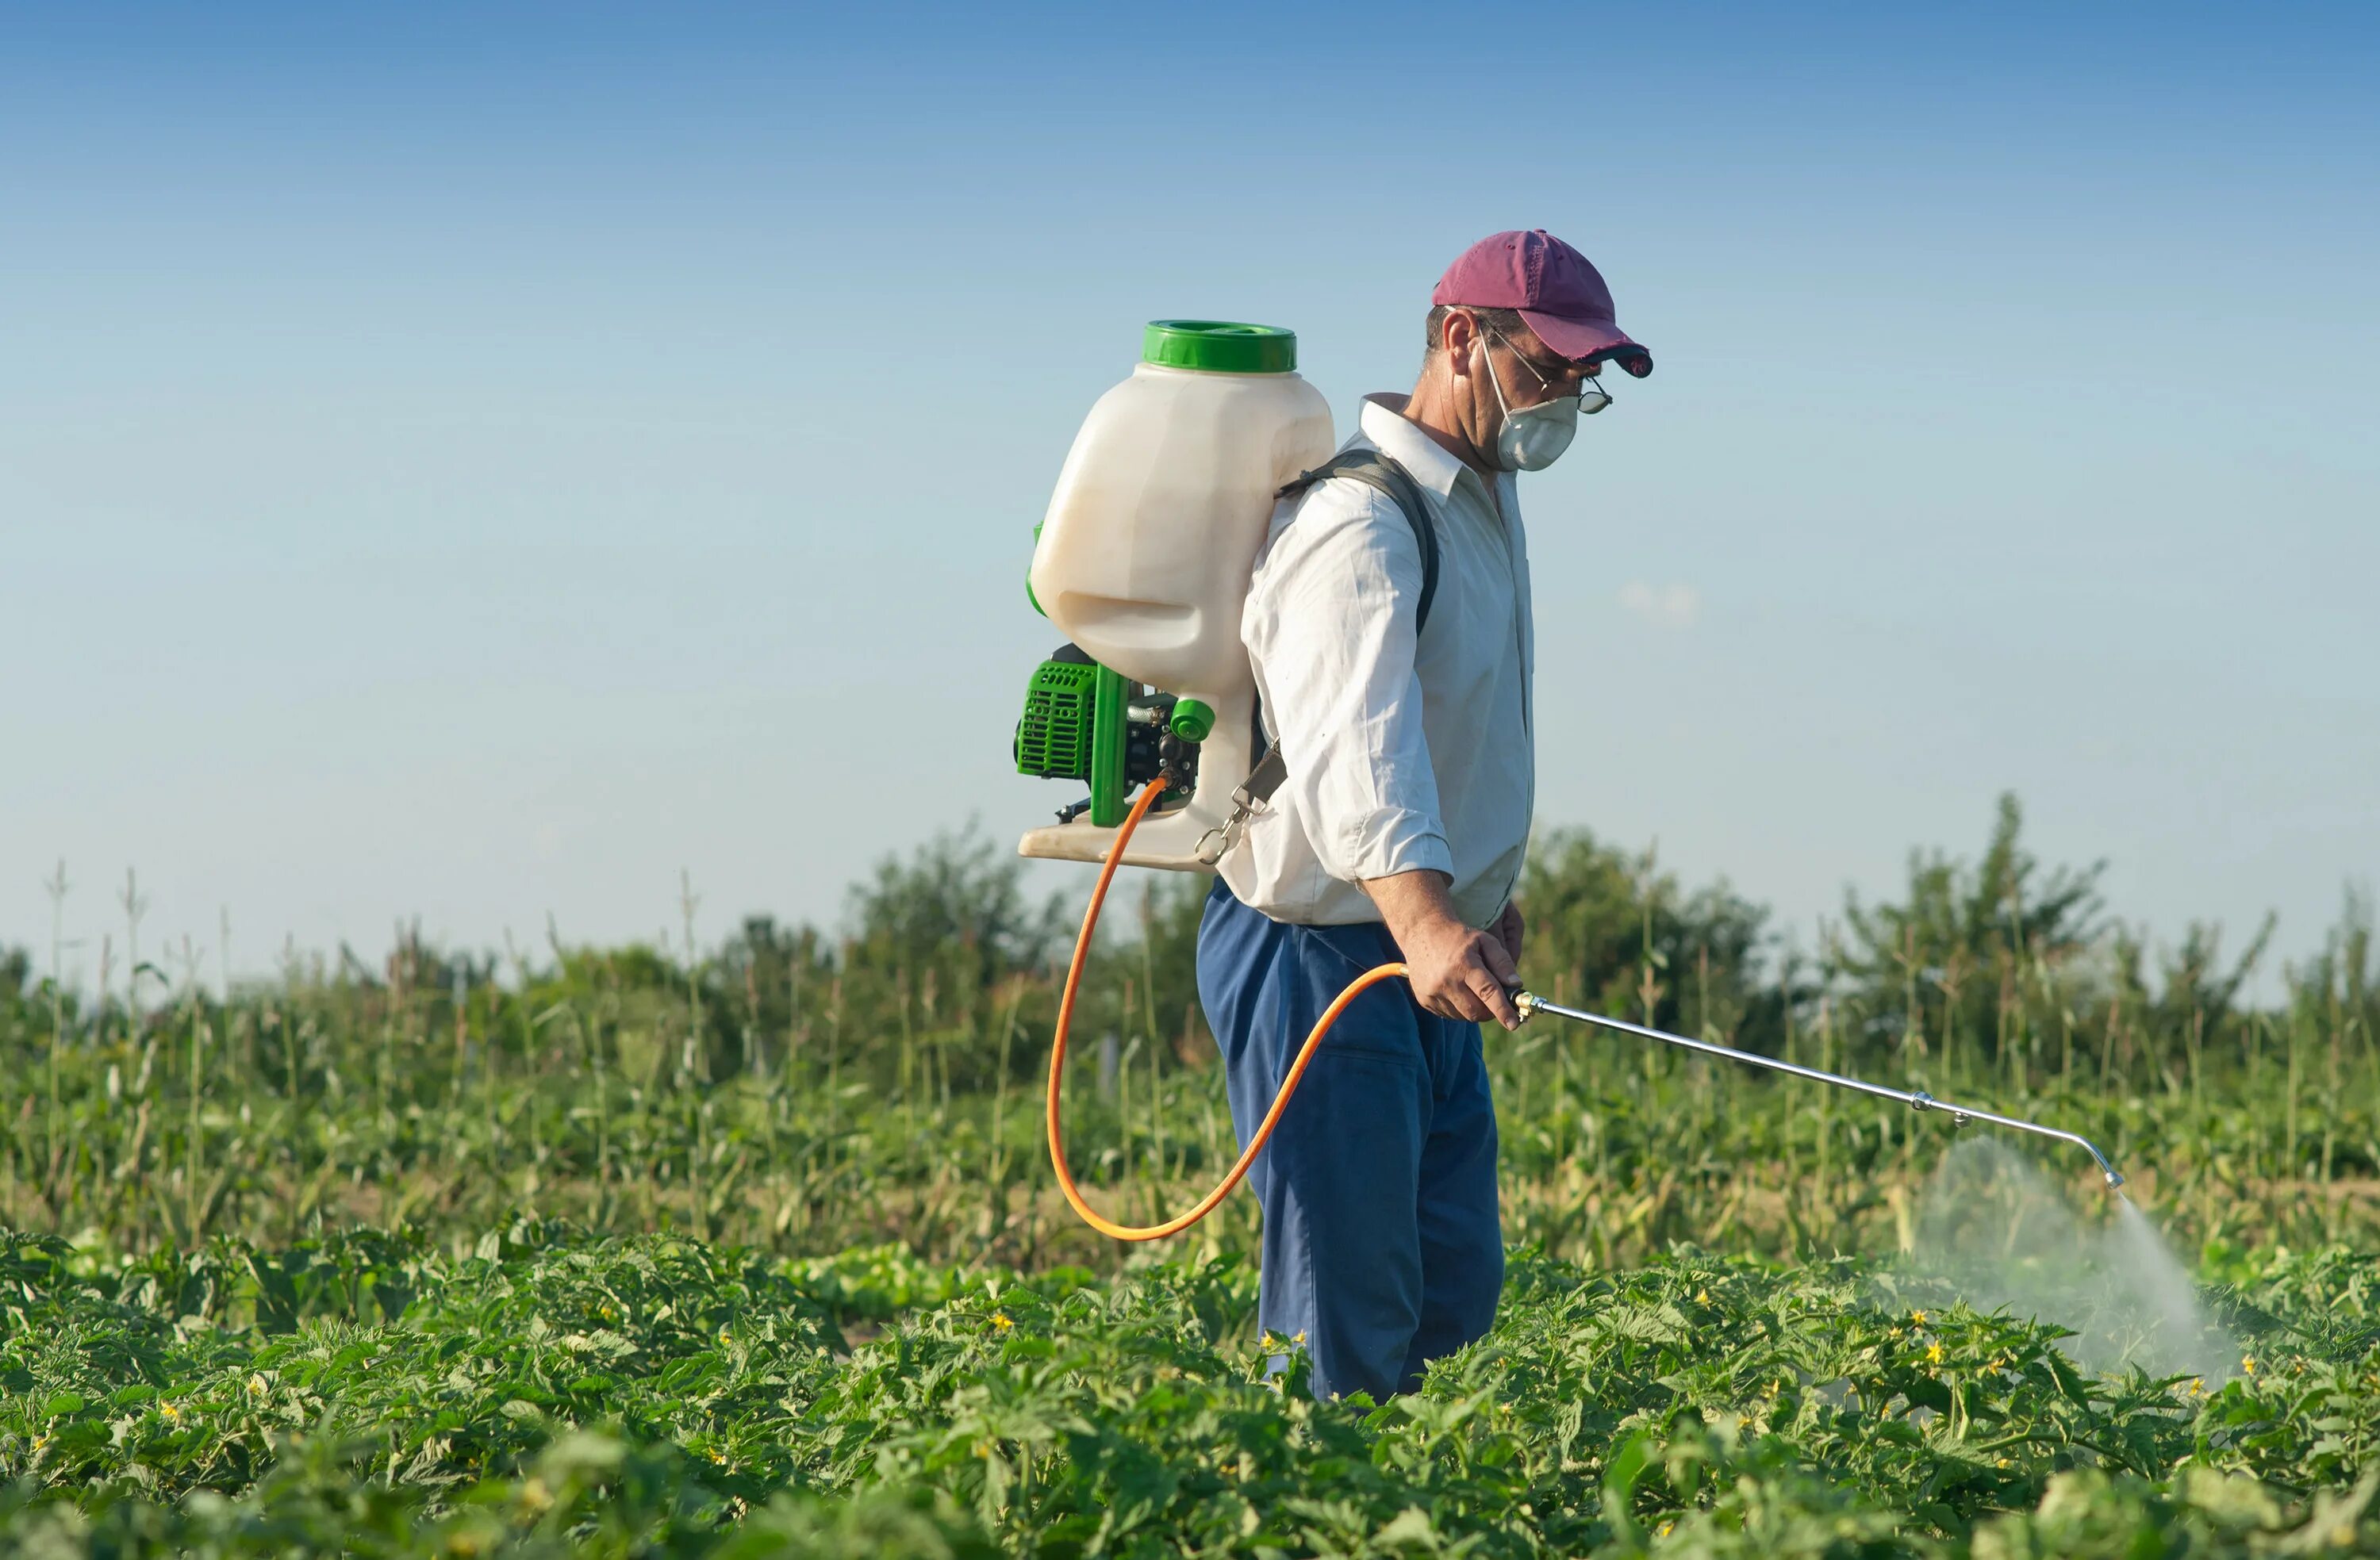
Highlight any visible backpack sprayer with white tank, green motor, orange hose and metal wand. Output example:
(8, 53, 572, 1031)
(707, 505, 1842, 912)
(1014, 319, 2123, 1241)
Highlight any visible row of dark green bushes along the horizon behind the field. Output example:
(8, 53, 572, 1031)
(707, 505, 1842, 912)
(0, 796, 2380, 1091)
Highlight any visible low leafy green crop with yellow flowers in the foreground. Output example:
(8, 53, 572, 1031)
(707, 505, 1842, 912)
(0, 1225, 2380, 1558)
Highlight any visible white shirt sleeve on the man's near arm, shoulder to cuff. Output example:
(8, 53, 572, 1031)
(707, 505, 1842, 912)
(1240, 481, 1454, 882)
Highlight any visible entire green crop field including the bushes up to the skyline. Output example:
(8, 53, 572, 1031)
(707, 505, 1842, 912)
(0, 806, 2380, 1558)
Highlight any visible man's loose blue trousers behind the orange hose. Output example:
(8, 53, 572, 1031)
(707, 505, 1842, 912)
(1197, 880, 1504, 1401)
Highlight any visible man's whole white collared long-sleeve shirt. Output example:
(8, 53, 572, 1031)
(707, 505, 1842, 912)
(1221, 395, 1537, 927)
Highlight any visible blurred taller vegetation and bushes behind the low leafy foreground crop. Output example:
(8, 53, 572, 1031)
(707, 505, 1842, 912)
(0, 808, 2380, 1267)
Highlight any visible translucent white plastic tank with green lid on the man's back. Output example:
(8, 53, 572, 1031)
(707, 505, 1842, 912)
(1031, 319, 1338, 727)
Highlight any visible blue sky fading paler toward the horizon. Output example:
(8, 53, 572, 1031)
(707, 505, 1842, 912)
(0, 2, 2380, 975)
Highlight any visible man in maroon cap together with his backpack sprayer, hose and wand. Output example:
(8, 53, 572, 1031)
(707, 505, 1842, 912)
(1014, 228, 2123, 1398)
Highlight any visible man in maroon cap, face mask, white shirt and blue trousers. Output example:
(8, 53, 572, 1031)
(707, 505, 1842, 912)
(1197, 228, 1652, 1398)
